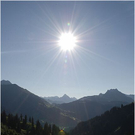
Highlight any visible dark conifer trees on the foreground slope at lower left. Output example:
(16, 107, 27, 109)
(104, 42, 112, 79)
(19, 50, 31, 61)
(1, 111, 65, 135)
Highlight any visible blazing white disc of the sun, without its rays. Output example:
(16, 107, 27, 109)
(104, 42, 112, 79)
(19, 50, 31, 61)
(58, 32, 76, 51)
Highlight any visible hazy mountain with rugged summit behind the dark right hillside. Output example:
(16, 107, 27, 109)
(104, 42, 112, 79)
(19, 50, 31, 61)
(57, 89, 133, 121)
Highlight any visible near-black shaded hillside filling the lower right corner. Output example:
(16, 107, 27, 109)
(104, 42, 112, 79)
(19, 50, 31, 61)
(70, 103, 134, 135)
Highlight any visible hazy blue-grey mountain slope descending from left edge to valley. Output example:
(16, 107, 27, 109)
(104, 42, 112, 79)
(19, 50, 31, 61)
(1, 80, 77, 126)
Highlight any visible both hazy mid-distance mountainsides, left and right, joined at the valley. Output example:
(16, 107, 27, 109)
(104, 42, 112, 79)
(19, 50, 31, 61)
(1, 81, 133, 127)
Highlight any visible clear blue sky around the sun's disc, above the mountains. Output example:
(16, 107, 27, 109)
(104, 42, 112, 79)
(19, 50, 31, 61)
(1, 1, 134, 98)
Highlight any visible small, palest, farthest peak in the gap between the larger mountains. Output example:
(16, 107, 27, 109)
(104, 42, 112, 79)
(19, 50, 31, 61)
(44, 94, 77, 104)
